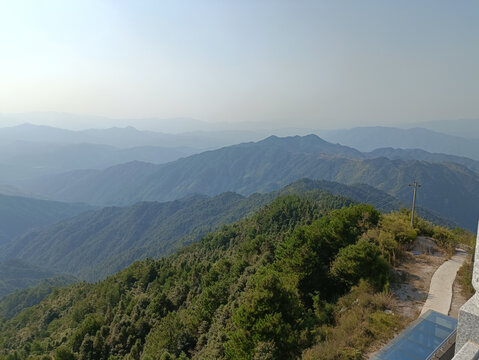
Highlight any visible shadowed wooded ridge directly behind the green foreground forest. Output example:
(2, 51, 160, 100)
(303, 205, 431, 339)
(1, 179, 434, 281)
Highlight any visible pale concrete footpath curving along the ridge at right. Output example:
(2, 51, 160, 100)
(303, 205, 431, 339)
(421, 250, 467, 315)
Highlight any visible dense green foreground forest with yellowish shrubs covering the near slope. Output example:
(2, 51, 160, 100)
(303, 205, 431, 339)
(0, 195, 471, 360)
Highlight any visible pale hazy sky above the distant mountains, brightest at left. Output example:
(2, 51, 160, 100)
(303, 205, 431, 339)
(0, 0, 479, 128)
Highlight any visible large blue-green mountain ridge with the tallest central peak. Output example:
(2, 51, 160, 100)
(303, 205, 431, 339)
(20, 135, 479, 229)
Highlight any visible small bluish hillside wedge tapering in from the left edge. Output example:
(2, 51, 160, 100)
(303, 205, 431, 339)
(0, 194, 93, 245)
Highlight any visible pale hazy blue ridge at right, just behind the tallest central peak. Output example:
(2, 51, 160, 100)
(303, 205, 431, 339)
(319, 126, 479, 160)
